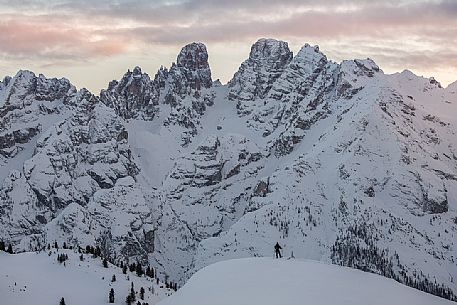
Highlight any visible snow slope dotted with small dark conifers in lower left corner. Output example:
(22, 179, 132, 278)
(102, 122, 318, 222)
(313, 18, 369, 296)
(0, 249, 172, 305)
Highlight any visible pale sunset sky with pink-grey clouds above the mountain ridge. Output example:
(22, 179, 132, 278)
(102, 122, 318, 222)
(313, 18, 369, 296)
(0, 0, 457, 93)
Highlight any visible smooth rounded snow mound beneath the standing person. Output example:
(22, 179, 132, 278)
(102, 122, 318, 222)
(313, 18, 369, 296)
(159, 258, 455, 305)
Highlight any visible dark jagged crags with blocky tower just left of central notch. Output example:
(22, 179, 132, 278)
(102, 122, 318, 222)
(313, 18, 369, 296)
(100, 42, 215, 146)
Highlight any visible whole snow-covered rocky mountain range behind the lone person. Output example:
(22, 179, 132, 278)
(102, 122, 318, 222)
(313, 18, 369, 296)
(0, 39, 457, 300)
